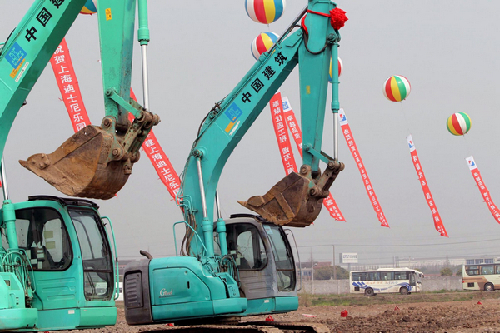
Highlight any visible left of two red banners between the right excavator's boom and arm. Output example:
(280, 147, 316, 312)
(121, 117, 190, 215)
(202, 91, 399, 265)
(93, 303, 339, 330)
(269, 91, 297, 175)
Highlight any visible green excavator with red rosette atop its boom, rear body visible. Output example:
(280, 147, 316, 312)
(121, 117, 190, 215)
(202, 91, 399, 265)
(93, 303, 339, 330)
(123, 0, 346, 325)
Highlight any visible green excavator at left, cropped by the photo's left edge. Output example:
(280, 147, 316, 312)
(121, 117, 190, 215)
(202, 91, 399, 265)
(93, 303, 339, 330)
(0, 0, 159, 331)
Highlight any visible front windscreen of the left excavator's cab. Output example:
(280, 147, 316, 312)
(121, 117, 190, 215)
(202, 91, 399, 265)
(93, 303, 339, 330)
(68, 207, 113, 300)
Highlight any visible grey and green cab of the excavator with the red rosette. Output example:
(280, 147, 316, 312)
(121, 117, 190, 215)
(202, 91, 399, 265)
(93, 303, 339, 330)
(222, 214, 298, 316)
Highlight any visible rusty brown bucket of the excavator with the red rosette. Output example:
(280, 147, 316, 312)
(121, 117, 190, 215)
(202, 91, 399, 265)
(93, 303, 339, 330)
(238, 172, 328, 227)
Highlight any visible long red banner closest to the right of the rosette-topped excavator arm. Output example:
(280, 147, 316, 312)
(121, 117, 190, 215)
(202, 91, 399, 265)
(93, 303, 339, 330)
(339, 109, 389, 227)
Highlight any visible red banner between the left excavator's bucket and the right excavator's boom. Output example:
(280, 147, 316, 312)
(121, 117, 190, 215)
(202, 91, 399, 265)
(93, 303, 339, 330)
(128, 96, 181, 200)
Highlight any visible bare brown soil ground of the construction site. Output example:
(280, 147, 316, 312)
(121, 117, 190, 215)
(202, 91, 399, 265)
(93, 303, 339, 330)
(68, 291, 500, 333)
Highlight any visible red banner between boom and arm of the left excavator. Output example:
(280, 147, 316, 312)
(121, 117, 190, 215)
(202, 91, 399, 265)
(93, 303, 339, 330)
(50, 38, 91, 132)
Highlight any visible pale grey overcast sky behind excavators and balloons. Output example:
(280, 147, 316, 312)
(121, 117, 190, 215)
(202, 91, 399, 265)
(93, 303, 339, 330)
(0, 0, 500, 264)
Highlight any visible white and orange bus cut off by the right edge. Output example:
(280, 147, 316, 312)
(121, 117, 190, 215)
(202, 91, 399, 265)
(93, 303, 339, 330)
(462, 263, 500, 291)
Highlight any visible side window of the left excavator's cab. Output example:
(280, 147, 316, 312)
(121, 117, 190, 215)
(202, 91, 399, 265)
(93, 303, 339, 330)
(2, 207, 73, 271)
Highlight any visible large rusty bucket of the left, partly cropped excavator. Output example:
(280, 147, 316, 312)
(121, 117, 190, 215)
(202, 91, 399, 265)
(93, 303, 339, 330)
(19, 126, 132, 200)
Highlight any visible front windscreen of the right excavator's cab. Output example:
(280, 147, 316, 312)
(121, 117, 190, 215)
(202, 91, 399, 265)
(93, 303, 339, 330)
(264, 225, 297, 291)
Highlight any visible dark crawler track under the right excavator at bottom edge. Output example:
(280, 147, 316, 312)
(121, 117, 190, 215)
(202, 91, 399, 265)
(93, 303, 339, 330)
(141, 321, 330, 333)
